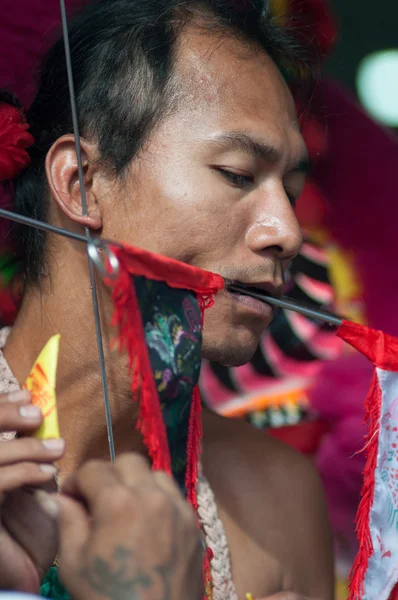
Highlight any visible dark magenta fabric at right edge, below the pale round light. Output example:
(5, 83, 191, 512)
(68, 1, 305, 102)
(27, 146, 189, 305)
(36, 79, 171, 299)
(313, 82, 398, 335)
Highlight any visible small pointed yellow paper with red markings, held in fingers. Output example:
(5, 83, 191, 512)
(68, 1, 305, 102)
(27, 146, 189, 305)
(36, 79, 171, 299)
(23, 334, 61, 440)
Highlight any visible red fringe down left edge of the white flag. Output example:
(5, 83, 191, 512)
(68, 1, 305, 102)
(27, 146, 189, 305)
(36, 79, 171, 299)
(348, 371, 381, 600)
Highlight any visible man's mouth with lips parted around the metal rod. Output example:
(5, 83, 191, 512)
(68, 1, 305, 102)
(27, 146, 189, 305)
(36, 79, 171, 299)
(225, 279, 283, 322)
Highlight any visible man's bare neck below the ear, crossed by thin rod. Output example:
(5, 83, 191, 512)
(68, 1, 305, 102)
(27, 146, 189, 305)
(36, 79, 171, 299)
(4, 267, 144, 473)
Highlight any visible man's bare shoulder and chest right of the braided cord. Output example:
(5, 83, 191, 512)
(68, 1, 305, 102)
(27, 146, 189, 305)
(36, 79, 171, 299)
(203, 413, 333, 600)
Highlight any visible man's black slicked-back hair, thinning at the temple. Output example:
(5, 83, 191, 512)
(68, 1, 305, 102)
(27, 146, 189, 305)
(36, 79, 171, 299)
(0, 0, 306, 282)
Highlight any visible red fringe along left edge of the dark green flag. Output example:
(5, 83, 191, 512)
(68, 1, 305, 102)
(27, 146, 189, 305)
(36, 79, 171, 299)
(109, 269, 171, 474)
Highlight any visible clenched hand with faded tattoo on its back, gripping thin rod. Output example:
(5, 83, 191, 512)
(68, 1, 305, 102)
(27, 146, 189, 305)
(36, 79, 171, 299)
(40, 454, 203, 600)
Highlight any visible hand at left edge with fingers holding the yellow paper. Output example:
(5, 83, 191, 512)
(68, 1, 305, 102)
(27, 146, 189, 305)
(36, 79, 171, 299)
(0, 391, 64, 592)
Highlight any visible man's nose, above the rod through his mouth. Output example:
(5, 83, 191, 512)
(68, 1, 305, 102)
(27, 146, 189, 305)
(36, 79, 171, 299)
(246, 188, 303, 261)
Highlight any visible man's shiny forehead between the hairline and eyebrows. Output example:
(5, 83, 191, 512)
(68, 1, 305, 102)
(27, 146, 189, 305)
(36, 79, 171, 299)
(176, 26, 303, 161)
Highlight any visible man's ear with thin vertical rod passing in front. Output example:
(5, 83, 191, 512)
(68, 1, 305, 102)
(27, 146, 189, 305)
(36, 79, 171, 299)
(46, 134, 102, 230)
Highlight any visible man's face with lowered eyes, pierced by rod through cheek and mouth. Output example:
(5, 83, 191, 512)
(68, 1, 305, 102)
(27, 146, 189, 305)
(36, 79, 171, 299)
(103, 28, 306, 365)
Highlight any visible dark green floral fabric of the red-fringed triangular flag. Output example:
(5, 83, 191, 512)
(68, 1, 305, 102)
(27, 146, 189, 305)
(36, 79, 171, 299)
(133, 277, 202, 492)
